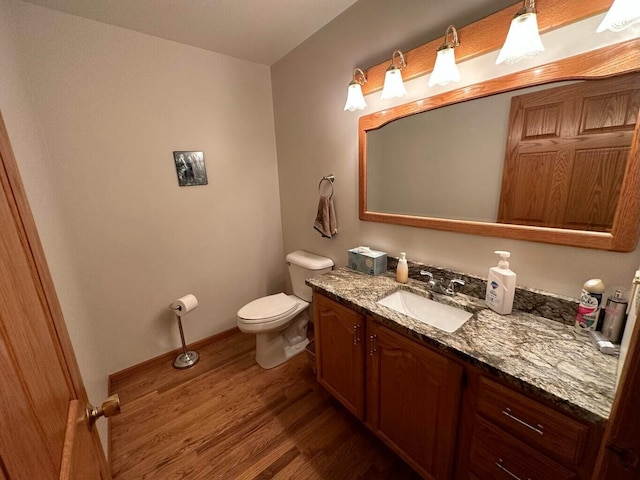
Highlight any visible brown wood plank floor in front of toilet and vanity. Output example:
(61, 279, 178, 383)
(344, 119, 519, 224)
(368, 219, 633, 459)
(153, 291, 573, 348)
(110, 332, 420, 480)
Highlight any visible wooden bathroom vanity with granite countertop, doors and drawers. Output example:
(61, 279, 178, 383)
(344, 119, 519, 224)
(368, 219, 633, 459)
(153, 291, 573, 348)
(307, 268, 617, 480)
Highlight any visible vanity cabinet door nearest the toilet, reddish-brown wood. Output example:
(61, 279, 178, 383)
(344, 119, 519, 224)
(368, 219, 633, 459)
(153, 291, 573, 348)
(313, 294, 364, 420)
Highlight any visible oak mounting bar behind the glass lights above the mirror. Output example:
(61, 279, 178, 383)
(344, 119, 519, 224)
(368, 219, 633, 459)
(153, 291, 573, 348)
(362, 0, 612, 95)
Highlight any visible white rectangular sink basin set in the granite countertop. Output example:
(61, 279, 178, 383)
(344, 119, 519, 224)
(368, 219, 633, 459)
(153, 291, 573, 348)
(377, 290, 473, 333)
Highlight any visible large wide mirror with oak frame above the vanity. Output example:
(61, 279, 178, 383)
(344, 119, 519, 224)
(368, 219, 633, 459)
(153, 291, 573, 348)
(359, 42, 640, 251)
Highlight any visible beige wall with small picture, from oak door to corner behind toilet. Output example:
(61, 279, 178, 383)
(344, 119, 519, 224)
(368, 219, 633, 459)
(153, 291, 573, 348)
(0, 0, 285, 446)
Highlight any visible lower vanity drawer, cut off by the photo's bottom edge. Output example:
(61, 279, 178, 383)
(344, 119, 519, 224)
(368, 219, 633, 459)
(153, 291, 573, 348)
(471, 416, 576, 480)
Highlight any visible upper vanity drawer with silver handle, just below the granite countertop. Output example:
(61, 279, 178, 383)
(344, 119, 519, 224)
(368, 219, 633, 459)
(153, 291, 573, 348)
(478, 377, 588, 466)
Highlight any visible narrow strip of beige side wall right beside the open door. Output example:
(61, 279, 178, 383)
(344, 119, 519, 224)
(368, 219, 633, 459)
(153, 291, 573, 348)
(0, 0, 112, 439)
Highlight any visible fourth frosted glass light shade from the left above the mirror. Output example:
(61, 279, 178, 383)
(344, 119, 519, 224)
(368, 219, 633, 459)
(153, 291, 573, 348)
(496, 0, 544, 65)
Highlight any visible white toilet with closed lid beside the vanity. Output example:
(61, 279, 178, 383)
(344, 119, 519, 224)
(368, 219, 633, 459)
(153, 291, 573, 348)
(238, 250, 333, 368)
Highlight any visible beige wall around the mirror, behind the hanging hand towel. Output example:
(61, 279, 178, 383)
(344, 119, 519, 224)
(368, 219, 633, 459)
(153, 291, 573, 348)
(272, 0, 640, 298)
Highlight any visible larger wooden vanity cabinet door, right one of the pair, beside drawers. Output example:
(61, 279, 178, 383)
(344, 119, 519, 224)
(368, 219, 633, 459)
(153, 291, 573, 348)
(366, 319, 463, 479)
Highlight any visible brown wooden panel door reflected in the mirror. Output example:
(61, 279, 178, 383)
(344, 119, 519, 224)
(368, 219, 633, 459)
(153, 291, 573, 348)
(498, 75, 640, 232)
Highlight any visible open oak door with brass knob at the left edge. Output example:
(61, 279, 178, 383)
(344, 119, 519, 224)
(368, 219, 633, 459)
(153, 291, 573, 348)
(0, 110, 110, 480)
